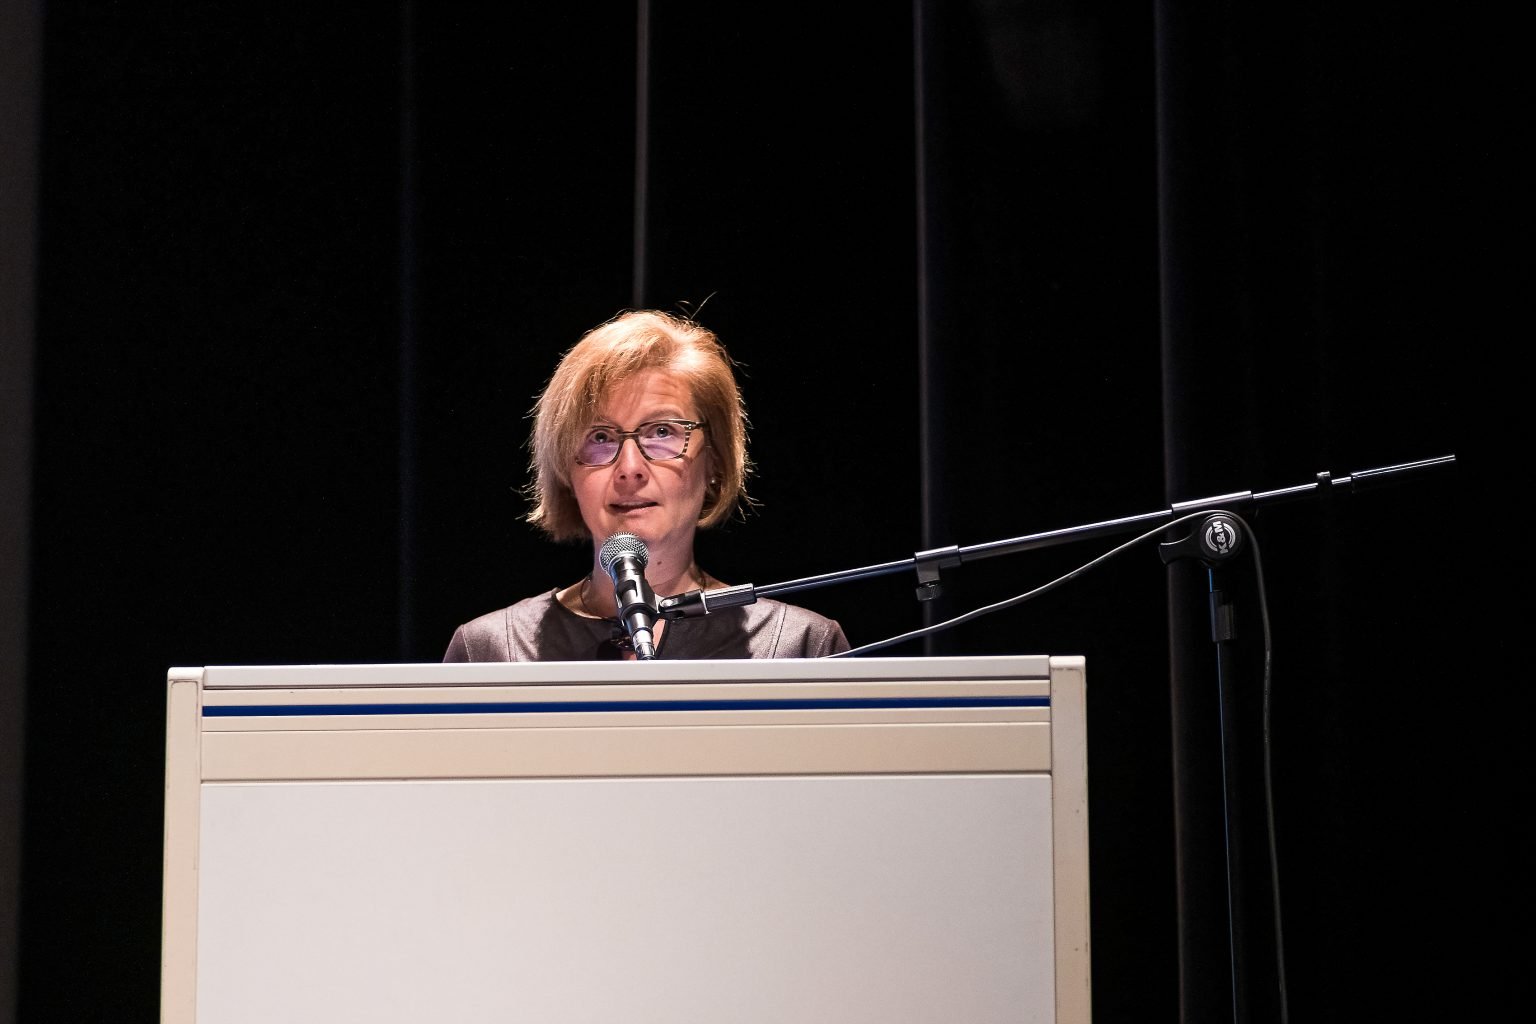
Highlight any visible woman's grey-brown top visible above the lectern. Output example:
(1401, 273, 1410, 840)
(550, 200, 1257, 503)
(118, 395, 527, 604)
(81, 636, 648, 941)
(442, 591, 848, 662)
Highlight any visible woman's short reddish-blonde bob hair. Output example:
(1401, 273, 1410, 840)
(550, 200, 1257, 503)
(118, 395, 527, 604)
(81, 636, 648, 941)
(527, 310, 751, 540)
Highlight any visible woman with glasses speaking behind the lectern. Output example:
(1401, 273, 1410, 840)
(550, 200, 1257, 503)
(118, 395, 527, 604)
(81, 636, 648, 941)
(442, 310, 848, 662)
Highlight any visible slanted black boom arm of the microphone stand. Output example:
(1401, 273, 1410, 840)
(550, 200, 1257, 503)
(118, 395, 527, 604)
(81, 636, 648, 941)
(657, 454, 1456, 619)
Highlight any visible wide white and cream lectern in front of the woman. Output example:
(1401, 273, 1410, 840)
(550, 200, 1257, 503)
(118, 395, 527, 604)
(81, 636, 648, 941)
(161, 656, 1089, 1024)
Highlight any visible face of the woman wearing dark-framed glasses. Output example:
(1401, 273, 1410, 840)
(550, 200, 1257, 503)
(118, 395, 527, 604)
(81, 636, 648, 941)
(571, 370, 714, 579)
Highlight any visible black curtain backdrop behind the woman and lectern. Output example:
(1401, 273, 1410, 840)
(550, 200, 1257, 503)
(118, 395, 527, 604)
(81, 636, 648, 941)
(0, 0, 1507, 1024)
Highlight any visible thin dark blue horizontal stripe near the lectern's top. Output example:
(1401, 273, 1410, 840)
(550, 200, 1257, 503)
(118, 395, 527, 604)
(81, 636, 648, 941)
(203, 697, 1051, 718)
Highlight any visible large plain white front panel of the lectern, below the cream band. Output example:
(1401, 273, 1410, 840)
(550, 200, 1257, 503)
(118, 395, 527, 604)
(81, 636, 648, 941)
(198, 775, 1055, 1024)
